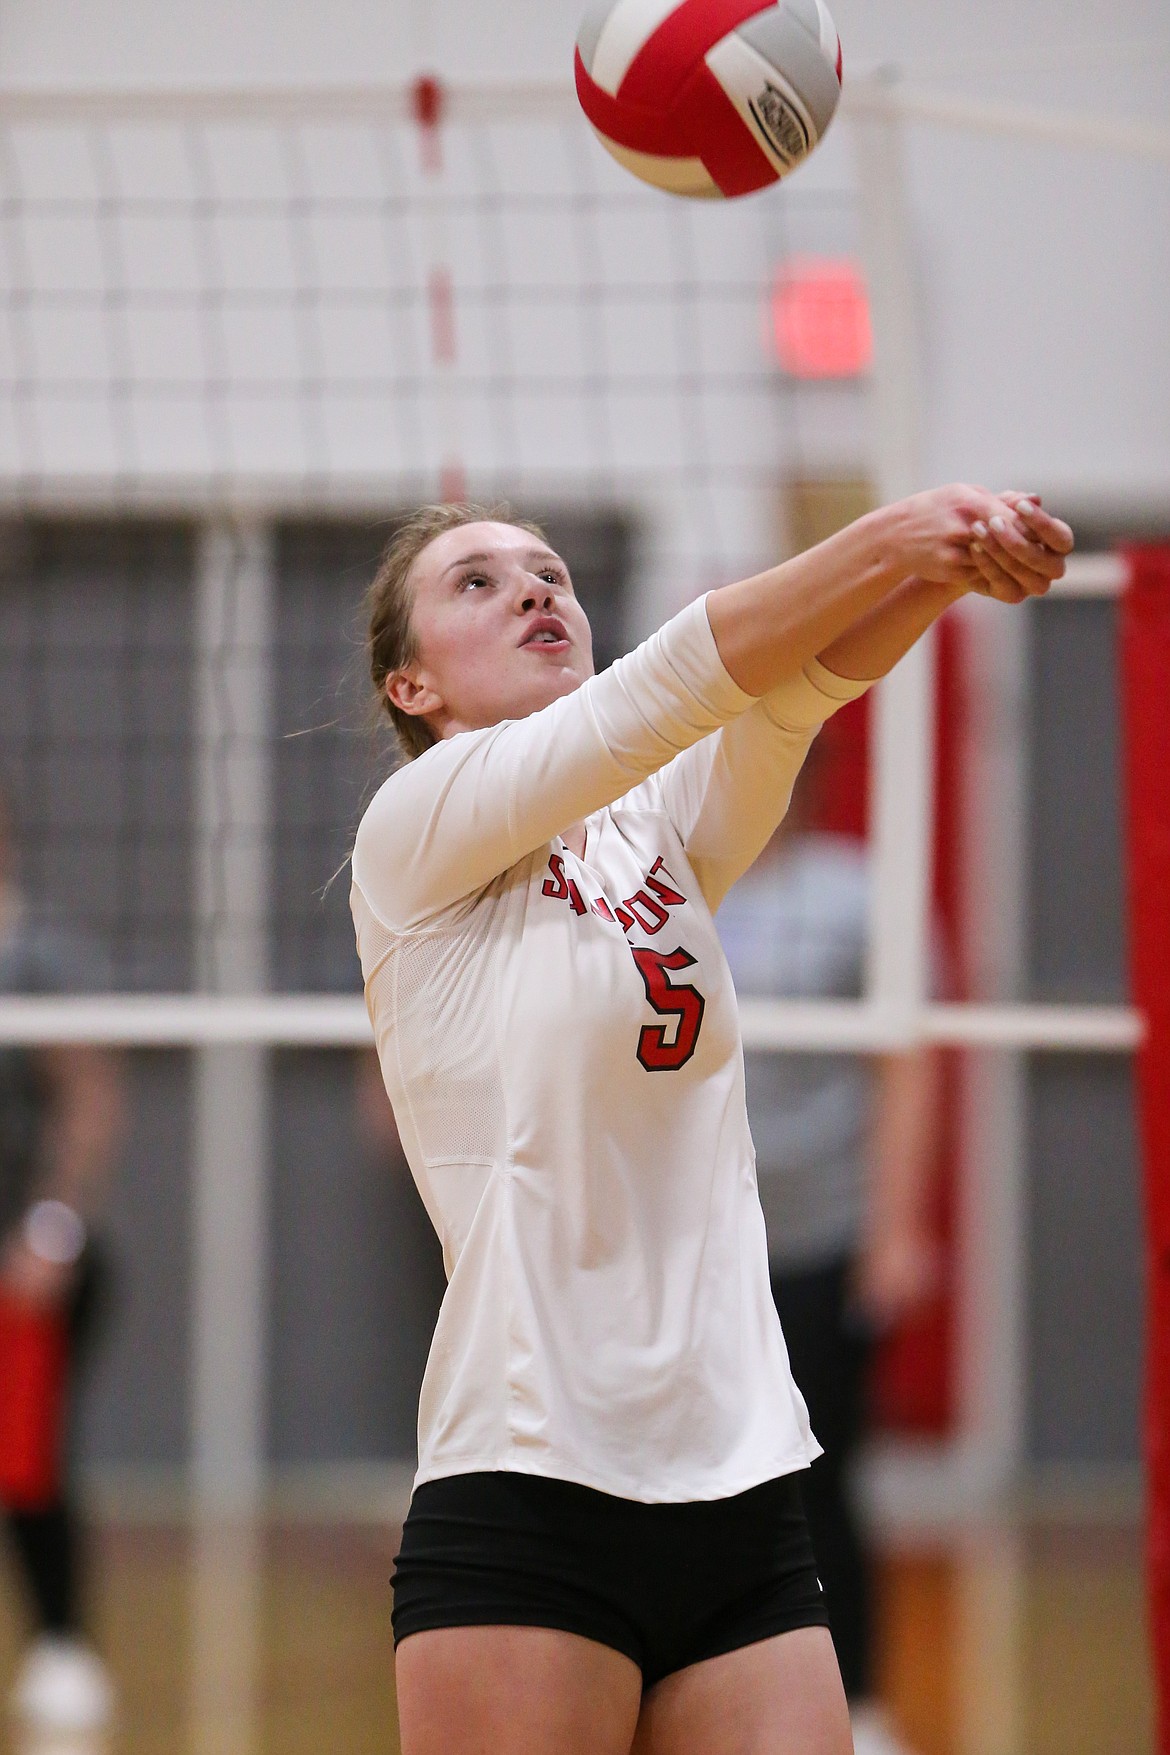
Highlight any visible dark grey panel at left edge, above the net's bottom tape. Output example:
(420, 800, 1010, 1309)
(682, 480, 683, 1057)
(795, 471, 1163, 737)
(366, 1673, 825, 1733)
(0, 519, 193, 992)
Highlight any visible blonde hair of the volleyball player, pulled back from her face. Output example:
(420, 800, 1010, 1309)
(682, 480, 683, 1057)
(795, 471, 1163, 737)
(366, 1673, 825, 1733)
(365, 500, 549, 762)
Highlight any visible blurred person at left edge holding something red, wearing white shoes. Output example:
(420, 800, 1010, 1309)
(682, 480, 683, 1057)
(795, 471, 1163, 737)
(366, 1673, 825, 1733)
(0, 797, 125, 1732)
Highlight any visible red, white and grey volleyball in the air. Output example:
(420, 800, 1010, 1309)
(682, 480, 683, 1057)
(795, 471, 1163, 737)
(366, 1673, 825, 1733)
(575, 0, 840, 198)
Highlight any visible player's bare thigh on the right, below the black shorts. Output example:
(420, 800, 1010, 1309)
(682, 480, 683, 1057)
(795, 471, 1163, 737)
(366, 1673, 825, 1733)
(631, 1627, 853, 1755)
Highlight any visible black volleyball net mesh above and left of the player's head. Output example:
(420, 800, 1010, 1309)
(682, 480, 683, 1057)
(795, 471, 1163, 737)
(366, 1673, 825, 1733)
(0, 95, 870, 993)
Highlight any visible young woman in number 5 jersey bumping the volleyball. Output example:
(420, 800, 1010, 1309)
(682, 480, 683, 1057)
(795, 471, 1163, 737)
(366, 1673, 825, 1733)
(353, 486, 1072, 1755)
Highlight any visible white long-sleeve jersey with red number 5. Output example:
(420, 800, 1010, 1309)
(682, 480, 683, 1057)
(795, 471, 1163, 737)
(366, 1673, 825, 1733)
(351, 600, 865, 1501)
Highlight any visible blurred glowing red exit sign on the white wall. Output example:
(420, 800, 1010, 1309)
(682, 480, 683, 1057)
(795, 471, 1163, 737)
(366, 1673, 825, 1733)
(768, 256, 874, 377)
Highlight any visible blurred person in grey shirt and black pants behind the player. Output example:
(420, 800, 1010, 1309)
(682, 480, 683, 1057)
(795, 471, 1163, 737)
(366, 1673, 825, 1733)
(717, 742, 940, 1755)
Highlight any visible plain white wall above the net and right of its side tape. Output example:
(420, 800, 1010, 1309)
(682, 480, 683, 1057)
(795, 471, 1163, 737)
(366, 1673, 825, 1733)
(0, 0, 1170, 519)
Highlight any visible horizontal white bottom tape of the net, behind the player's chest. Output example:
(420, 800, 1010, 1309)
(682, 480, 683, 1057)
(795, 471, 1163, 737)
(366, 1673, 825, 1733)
(0, 993, 1142, 1053)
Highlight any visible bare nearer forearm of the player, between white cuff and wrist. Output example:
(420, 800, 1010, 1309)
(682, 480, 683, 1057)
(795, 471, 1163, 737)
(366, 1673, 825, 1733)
(707, 505, 914, 695)
